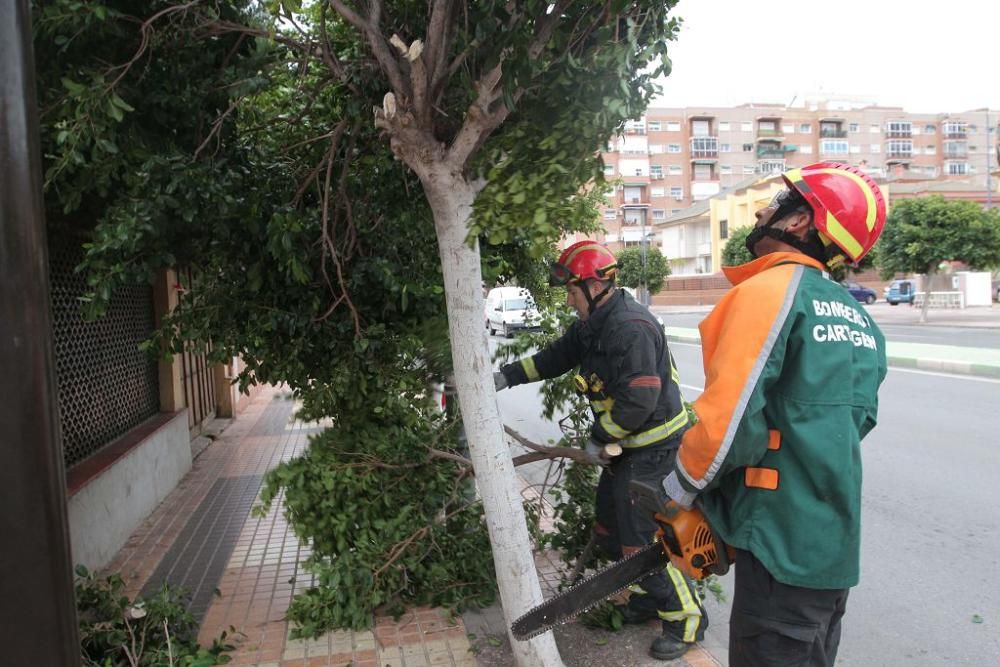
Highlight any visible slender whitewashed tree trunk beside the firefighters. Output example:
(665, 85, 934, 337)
(423, 171, 562, 667)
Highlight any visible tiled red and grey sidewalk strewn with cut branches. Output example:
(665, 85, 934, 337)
(106, 388, 724, 667)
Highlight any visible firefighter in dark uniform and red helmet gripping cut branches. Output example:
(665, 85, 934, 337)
(494, 241, 708, 660)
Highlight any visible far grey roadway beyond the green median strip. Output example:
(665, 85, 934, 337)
(660, 303, 1000, 348)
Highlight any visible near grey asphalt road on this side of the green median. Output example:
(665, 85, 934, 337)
(490, 336, 1000, 667)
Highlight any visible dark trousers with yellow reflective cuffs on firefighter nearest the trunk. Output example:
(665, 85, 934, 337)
(594, 438, 708, 642)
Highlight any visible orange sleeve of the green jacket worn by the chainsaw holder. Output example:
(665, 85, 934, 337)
(678, 264, 797, 486)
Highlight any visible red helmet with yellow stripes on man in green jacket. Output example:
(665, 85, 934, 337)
(782, 162, 885, 262)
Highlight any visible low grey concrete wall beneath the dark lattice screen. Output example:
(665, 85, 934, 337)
(68, 410, 191, 570)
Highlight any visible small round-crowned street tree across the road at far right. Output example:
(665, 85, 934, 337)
(878, 195, 1000, 322)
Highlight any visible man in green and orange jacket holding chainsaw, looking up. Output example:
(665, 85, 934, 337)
(663, 163, 886, 667)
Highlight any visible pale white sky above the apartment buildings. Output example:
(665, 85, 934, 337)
(652, 0, 1000, 113)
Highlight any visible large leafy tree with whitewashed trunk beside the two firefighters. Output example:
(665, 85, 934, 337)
(45, 0, 677, 664)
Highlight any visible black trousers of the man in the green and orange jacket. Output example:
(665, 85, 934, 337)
(729, 549, 850, 667)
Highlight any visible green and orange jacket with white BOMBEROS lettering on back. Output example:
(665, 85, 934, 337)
(663, 253, 886, 589)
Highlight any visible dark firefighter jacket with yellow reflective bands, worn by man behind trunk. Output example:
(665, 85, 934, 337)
(500, 290, 688, 449)
